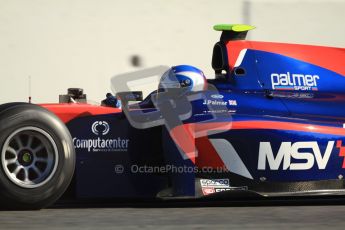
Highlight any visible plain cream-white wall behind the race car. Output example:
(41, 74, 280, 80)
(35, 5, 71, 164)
(0, 0, 345, 103)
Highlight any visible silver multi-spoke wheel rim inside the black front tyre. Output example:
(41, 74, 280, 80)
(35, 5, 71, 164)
(1, 127, 59, 188)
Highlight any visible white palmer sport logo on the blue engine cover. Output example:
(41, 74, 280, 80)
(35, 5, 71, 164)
(271, 72, 320, 91)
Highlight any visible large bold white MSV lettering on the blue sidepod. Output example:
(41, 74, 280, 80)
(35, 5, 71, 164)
(258, 141, 335, 170)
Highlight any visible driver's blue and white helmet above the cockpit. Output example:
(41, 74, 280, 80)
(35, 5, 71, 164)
(158, 65, 207, 92)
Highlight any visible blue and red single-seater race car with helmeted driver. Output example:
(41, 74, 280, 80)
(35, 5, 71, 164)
(0, 24, 345, 209)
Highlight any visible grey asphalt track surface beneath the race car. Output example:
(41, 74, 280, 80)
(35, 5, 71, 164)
(0, 200, 345, 230)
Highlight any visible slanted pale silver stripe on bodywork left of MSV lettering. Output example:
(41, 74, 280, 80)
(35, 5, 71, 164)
(210, 139, 253, 179)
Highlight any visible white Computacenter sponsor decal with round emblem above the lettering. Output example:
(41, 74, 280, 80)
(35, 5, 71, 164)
(72, 121, 129, 152)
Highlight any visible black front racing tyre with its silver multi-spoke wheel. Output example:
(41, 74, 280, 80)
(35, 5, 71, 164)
(0, 103, 75, 209)
